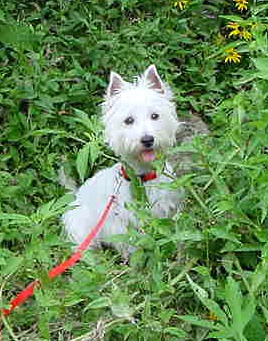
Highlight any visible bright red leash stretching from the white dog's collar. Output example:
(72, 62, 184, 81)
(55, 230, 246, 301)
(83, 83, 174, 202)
(0, 175, 121, 316)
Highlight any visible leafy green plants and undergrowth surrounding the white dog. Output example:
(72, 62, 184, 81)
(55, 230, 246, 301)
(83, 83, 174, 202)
(0, 0, 268, 341)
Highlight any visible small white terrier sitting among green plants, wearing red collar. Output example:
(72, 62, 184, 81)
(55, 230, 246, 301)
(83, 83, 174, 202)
(63, 65, 184, 258)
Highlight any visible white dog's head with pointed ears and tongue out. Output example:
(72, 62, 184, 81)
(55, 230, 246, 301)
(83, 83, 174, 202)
(103, 65, 178, 163)
